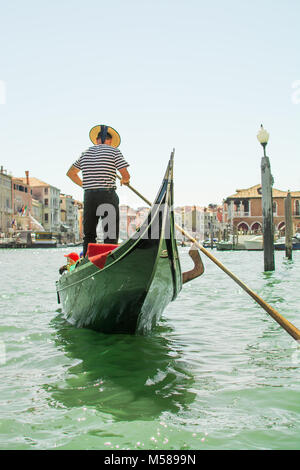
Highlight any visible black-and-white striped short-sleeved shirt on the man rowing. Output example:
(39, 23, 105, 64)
(73, 144, 129, 189)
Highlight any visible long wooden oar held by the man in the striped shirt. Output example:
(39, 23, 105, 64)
(118, 175, 300, 341)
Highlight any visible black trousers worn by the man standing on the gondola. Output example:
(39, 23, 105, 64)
(83, 189, 120, 256)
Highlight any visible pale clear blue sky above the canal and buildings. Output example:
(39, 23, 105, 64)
(0, 0, 300, 207)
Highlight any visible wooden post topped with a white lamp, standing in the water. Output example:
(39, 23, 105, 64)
(257, 125, 275, 271)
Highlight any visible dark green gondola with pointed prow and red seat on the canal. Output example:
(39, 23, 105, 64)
(56, 154, 182, 334)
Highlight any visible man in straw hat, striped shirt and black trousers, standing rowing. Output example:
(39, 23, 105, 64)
(67, 124, 130, 256)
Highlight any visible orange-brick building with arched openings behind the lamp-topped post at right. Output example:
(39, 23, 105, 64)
(223, 184, 300, 235)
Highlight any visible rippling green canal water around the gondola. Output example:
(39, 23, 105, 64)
(0, 248, 300, 450)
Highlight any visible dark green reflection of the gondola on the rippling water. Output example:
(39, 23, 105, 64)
(45, 316, 195, 421)
